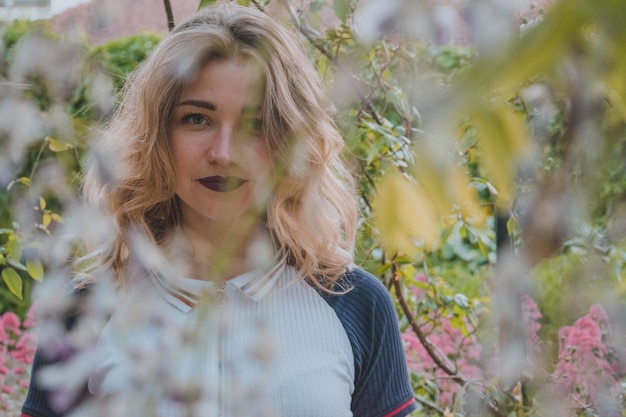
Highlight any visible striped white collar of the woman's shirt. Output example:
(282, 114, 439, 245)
(151, 255, 287, 313)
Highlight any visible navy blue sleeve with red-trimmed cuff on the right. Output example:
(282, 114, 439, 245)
(323, 269, 416, 417)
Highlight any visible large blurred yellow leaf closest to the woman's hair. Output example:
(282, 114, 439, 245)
(374, 171, 439, 255)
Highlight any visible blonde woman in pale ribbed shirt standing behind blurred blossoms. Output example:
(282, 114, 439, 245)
(23, 4, 415, 417)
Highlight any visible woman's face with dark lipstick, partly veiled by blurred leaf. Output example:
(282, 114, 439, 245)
(169, 58, 272, 228)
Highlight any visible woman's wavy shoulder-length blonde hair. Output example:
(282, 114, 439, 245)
(83, 4, 357, 291)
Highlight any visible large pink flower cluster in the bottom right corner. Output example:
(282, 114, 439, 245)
(553, 304, 626, 406)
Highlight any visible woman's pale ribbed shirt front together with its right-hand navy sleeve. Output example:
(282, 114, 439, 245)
(24, 265, 415, 417)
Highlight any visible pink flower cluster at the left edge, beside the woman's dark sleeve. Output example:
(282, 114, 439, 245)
(0, 308, 37, 415)
